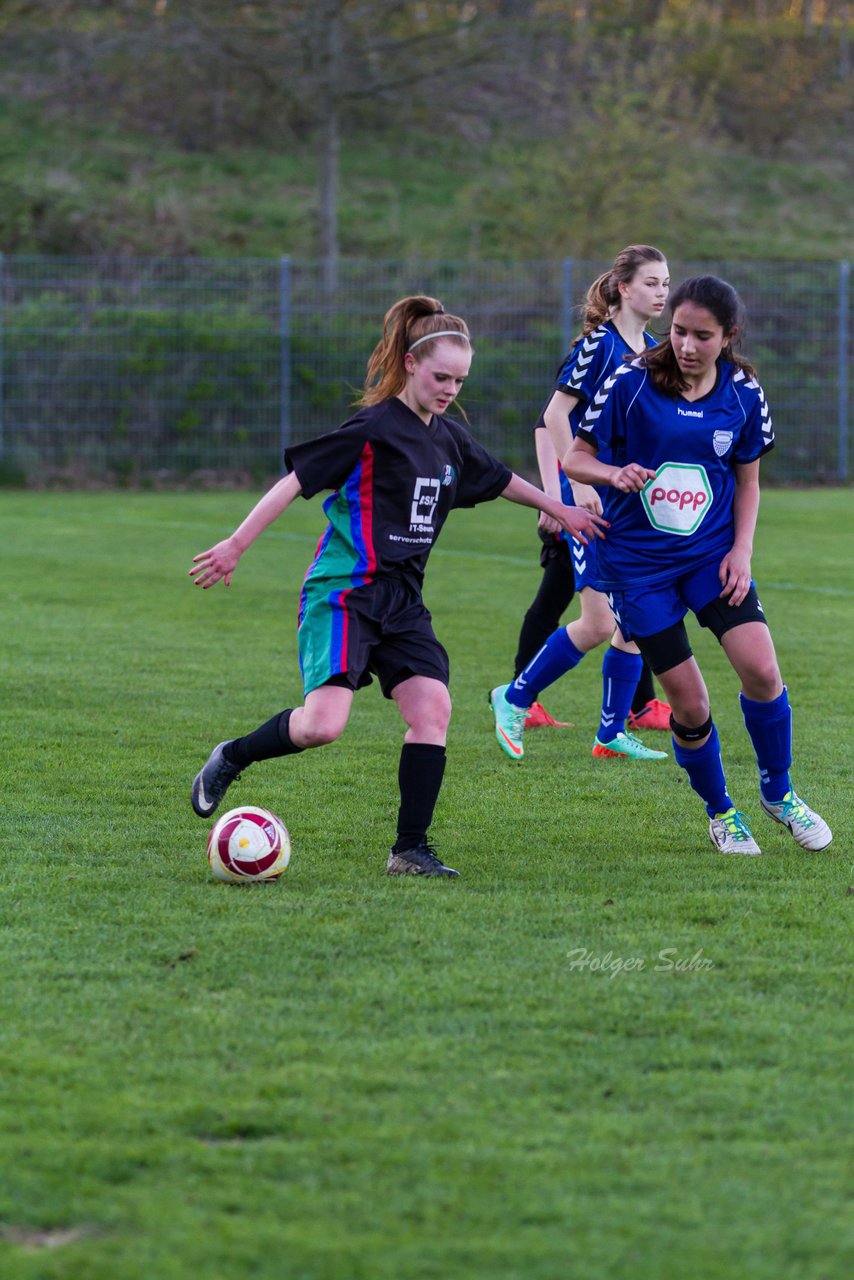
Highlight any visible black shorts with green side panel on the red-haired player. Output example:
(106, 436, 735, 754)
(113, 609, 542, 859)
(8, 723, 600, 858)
(298, 577, 451, 698)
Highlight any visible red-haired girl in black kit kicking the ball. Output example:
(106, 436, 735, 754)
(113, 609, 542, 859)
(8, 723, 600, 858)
(189, 296, 603, 876)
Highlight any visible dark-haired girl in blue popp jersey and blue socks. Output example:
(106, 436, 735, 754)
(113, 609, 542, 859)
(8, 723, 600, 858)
(565, 275, 832, 854)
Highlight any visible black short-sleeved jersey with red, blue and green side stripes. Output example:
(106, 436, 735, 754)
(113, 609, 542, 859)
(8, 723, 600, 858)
(284, 397, 512, 586)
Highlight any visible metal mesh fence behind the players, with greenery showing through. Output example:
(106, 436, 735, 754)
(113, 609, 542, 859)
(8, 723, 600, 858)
(0, 256, 851, 484)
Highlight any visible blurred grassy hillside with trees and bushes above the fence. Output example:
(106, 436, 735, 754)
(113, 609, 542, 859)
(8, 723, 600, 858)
(0, 0, 851, 261)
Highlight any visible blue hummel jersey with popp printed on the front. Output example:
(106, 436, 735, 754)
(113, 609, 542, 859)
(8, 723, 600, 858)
(579, 360, 775, 590)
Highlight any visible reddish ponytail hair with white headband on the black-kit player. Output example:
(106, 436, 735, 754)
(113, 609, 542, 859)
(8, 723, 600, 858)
(359, 294, 471, 404)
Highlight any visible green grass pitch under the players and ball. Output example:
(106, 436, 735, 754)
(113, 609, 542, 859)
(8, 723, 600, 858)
(0, 492, 854, 1280)
